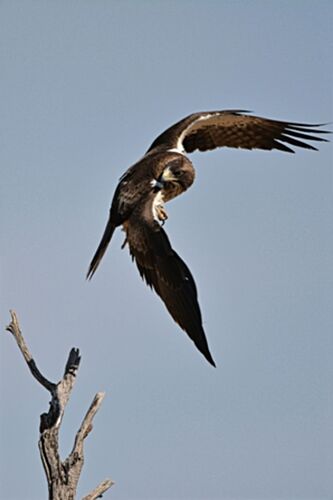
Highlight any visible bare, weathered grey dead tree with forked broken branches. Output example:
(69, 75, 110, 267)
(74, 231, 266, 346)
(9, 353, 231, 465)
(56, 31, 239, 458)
(7, 311, 113, 500)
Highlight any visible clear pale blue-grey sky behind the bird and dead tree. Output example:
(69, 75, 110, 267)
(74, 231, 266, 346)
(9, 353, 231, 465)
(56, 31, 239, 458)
(0, 0, 333, 500)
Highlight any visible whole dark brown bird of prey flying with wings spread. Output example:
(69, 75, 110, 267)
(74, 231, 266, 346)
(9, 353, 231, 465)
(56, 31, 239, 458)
(87, 110, 327, 366)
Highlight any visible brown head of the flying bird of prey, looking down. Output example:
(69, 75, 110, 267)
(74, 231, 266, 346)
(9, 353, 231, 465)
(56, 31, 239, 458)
(159, 158, 195, 201)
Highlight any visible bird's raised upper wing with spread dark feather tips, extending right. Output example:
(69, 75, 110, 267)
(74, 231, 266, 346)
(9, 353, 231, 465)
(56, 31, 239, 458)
(148, 110, 329, 153)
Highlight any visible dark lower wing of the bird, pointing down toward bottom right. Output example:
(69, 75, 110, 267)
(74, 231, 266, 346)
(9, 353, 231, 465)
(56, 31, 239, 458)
(124, 201, 215, 366)
